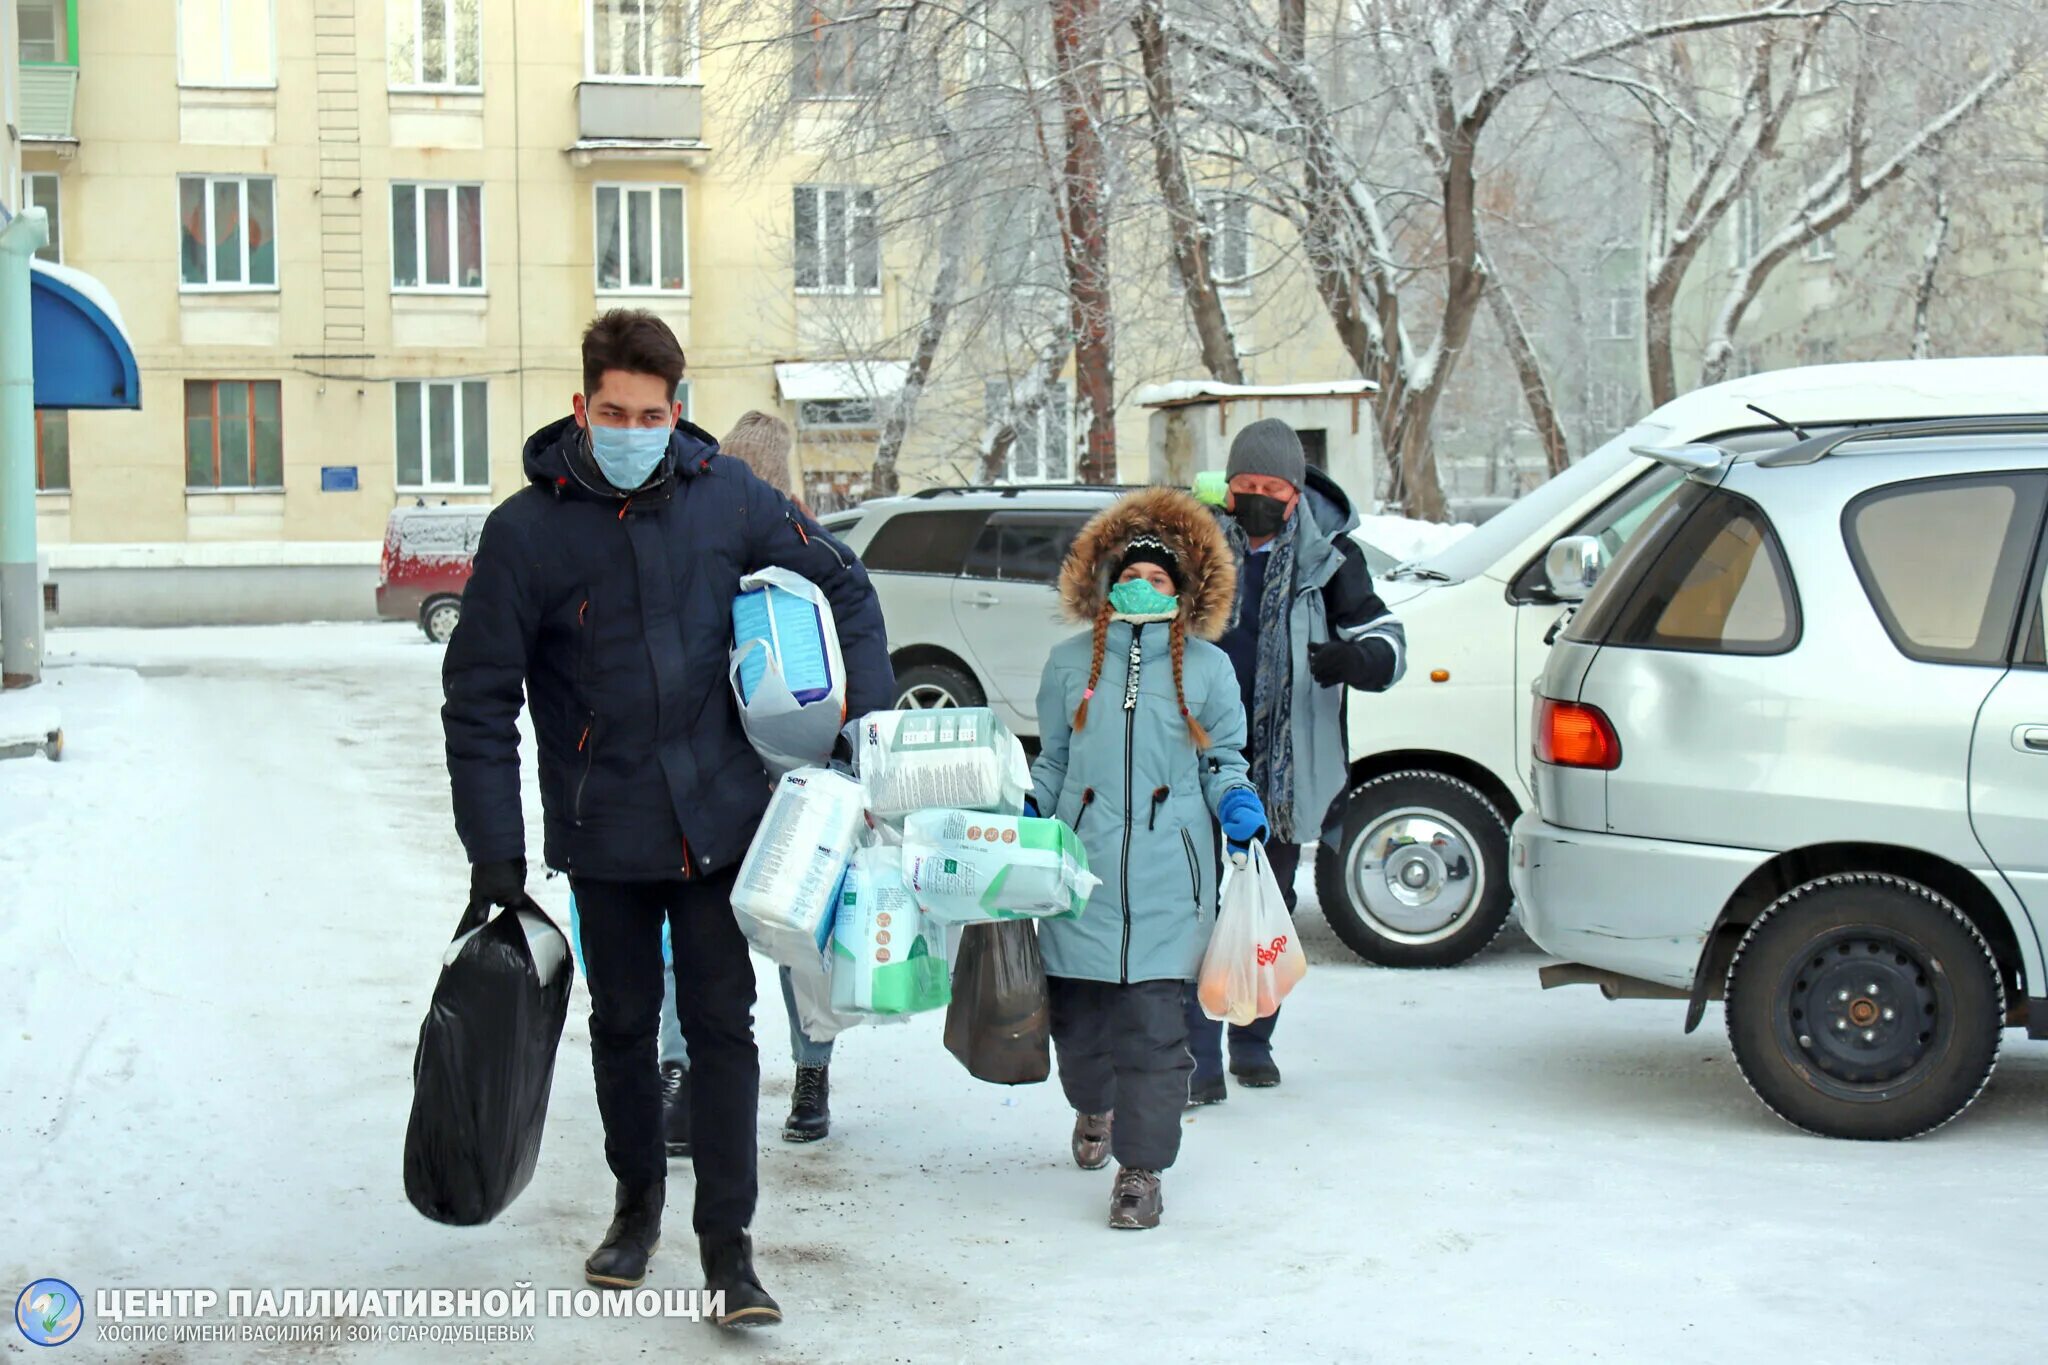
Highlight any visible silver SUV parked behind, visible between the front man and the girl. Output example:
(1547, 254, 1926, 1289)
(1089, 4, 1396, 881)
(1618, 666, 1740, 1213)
(823, 487, 1124, 737)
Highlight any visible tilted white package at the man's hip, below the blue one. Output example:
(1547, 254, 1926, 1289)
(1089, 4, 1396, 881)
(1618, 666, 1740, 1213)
(733, 767, 866, 964)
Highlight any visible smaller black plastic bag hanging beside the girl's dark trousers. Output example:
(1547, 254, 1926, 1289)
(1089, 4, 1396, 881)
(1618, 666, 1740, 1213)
(946, 919, 1053, 1085)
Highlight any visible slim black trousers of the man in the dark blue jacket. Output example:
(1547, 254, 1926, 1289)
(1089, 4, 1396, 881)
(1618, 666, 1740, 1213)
(569, 872, 762, 1234)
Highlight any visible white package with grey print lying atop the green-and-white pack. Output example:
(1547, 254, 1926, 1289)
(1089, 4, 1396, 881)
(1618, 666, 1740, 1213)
(854, 706, 1030, 821)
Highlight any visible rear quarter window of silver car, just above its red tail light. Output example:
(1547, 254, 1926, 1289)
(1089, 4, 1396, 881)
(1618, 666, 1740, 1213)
(1567, 483, 1800, 655)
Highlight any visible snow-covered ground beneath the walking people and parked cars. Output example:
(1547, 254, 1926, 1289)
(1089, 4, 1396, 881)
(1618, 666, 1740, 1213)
(0, 626, 2048, 1365)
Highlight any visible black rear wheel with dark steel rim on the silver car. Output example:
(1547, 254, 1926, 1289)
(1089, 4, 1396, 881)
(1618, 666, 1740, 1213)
(1726, 872, 2005, 1140)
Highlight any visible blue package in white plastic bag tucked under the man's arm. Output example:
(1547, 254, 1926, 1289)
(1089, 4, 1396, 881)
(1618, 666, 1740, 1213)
(727, 569, 846, 776)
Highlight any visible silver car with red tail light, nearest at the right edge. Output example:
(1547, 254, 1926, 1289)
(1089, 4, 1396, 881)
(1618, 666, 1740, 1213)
(1511, 415, 2048, 1138)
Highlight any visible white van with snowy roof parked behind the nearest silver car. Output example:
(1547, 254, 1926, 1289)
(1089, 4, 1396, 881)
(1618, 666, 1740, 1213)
(1315, 356, 2048, 966)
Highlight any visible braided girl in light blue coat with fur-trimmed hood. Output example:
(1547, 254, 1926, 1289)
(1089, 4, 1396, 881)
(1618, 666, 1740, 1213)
(1032, 489, 1266, 1228)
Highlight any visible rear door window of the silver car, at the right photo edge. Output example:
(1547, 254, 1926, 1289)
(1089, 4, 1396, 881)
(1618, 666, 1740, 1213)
(1841, 473, 2048, 665)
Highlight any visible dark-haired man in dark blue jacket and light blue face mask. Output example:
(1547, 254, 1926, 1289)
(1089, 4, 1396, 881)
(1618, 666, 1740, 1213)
(442, 309, 893, 1326)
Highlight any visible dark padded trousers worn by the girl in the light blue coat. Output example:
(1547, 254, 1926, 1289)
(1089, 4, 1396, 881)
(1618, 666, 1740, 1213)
(1047, 976, 1194, 1171)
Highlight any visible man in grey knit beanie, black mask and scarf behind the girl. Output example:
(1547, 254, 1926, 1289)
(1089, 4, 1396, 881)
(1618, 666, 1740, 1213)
(1188, 417, 1407, 1105)
